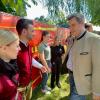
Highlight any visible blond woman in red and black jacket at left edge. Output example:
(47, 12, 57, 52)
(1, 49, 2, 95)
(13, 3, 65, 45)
(0, 30, 22, 100)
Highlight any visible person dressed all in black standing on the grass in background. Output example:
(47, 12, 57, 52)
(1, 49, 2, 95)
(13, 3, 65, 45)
(51, 39, 65, 89)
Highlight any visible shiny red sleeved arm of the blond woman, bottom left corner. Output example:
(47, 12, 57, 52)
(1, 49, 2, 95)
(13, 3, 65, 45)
(0, 75, 17, 100)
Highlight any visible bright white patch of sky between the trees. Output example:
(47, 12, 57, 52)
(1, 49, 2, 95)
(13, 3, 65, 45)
(27, 0, 48, 19)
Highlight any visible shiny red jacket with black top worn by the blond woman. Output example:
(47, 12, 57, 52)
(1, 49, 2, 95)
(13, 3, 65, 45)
(0, 59, 22, 100)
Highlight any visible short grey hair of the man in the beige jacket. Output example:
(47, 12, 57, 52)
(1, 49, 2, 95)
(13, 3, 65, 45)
(67, 13, 85, 23)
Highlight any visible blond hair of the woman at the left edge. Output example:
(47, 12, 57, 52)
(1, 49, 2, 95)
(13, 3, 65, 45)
(0, 30, 19, 46)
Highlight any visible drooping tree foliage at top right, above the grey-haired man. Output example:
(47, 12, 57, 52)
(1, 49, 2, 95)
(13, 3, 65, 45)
(40, 0, 100, 25)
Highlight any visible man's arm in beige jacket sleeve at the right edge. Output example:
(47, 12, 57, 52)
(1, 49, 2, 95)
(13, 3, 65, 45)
(91, 37, 100, 100)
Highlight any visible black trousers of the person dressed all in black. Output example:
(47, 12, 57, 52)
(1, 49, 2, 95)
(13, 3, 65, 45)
(51, 58, 62, 87)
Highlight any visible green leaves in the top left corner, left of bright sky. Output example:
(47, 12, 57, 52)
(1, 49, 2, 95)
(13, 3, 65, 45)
(0, 0, 26, 16)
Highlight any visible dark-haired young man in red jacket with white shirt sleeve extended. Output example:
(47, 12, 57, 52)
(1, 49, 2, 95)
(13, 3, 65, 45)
(16, 19, 46, 90)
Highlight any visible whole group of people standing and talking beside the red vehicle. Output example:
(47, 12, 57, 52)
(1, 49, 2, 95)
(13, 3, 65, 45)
(0, 13, 100, 100)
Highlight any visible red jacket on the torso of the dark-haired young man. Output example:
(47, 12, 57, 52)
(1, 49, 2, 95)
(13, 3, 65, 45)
(17, 42, 32, 86)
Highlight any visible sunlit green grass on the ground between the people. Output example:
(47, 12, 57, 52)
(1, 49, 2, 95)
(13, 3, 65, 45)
(31, 75, 92, 100)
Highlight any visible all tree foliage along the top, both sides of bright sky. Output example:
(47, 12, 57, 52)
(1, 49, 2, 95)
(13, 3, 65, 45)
(0, 0, 100, 27)
